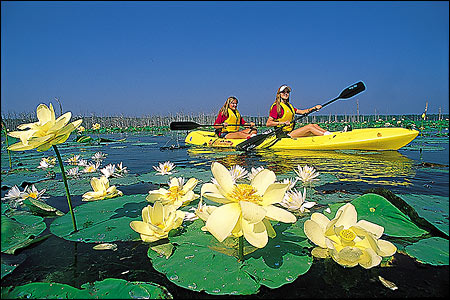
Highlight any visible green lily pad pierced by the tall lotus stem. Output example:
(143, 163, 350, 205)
(50, 195, 149, 243)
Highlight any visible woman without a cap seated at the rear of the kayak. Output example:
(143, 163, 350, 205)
(214, 97, 256, 139)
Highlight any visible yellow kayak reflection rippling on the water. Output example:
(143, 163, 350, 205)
(188, 148, 415, 186)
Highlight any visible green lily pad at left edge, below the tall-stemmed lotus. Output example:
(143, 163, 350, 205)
(1, 215, 47, 254)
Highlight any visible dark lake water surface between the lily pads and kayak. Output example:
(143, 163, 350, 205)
(1, 133, 449, 299)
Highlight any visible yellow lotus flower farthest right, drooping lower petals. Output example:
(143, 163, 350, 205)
(304, 203, 397, 269)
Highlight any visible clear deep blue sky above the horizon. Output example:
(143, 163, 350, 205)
(1, 1, 449, 116)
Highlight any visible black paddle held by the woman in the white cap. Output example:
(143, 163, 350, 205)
(236, 81, 366, 151)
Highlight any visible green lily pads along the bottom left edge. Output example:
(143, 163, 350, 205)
(1, 278, 173, 299)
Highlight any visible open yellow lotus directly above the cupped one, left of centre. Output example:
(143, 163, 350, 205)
(145, 177, 199, 208)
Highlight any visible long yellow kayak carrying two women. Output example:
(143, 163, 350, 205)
(185, 128, 419, 151)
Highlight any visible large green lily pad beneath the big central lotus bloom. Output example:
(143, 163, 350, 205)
(148, 220, 312, 295)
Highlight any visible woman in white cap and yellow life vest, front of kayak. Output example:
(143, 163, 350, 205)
(266, 85, 330, 138)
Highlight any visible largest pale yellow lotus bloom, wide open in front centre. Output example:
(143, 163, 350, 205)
(201, 162, 296, 248)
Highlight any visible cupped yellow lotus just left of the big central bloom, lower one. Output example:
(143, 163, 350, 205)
(130, 201, 184, 242)
